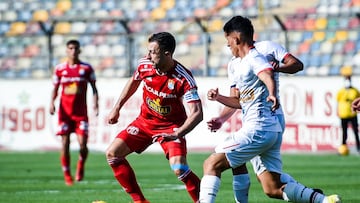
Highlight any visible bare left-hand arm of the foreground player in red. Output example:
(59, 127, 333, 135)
(108, 77, 141, 124)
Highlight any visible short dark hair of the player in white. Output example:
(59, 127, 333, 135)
(223, 16, 254, 42)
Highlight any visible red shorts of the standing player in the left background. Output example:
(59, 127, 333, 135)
(56, 120, 89, 137)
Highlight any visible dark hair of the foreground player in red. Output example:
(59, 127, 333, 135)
(148, 32, 176, 53)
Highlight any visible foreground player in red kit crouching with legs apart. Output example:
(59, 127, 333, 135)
(106, 32, 203, 203)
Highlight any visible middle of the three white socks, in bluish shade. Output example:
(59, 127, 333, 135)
(233, 173, 250, 203)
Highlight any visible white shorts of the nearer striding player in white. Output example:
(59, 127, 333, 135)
(215, 128, 282, 174)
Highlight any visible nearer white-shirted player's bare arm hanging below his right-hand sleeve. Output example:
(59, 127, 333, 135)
(257, 69, 280, 111)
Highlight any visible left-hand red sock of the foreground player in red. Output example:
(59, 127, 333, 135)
(110, 158, 145, 201)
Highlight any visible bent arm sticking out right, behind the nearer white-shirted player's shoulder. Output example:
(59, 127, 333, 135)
(272, 54, 304, 74)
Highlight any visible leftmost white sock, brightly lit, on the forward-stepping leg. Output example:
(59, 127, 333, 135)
(199, 175, 221, 203)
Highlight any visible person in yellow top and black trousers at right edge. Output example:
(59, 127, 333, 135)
(336, 67, 360, 152)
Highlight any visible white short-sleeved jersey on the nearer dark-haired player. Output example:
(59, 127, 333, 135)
(228, 48, 282, 132)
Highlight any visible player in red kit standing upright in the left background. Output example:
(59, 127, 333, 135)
(50, 40, 98, 185)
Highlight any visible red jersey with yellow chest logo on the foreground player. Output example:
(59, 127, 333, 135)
(133, 58, 200, 128)
